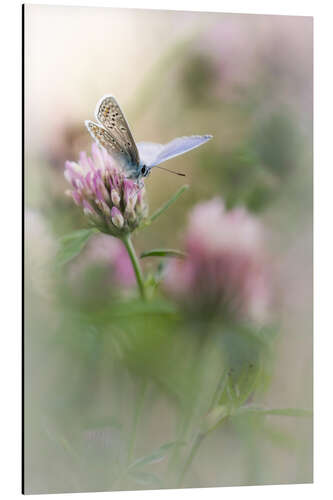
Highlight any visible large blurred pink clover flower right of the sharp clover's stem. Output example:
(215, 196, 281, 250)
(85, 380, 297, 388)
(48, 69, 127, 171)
(165, 198, 270, 322)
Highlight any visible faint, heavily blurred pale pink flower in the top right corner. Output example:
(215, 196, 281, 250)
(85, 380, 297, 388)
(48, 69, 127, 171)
(200, 15, 312, 114)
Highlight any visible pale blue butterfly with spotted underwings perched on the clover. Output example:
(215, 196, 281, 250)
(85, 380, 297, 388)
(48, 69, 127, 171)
(85, 95, 212, 185)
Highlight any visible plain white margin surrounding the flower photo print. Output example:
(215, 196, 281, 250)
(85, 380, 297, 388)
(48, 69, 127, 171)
(0, 0, 333, 500)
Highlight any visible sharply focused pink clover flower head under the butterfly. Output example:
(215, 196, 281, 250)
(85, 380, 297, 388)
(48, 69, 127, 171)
(64, 143, 148, 238)
